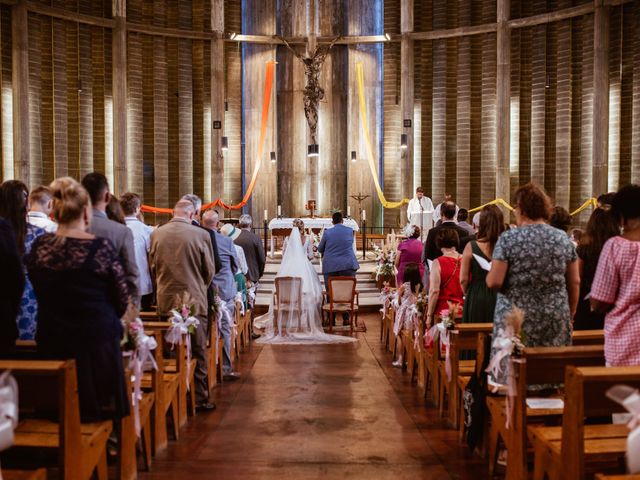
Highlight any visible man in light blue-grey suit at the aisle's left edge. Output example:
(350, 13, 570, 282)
(202, 210, 240, 380)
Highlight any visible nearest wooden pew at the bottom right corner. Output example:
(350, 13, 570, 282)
(528, 366, 640, 480)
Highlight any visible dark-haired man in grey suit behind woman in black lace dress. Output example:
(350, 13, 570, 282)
(82, 172, 140, 305)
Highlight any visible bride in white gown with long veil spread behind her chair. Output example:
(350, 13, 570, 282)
(254, 222, 357, 344)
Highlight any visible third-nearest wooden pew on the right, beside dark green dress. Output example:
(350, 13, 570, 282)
(438, 323, 493, 428)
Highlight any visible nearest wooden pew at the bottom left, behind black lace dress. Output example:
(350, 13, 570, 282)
(0, 360, 112, 480)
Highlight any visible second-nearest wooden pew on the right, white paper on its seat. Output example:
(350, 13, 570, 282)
(487, 345, 604, 480)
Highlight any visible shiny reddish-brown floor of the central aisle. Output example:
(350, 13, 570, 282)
(140, 314, 484, 480)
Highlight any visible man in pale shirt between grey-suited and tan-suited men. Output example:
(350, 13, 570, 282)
(120, 192, 153, 310)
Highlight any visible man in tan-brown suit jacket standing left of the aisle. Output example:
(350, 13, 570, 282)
(149, 200, 216, 410)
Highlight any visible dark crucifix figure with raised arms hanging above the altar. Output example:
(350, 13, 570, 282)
(281, 36, 340, 143)
